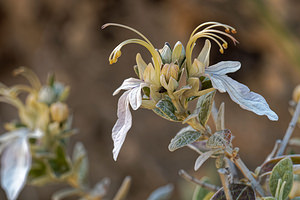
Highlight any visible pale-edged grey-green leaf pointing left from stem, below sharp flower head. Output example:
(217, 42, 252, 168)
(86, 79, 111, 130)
(169, 126, 202, 151)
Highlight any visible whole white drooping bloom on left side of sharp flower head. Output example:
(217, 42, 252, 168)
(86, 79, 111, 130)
(112, 78, 147, 160)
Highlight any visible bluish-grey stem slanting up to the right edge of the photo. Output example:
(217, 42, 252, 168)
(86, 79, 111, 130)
(276, 100, 300, 156)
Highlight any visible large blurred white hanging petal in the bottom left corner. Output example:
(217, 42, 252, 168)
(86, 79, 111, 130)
(1, 136, 31, 200)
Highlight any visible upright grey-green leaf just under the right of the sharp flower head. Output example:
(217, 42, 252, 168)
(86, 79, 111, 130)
(196, 90, 216, 126)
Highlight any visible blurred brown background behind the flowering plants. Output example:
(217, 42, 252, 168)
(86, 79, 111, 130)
(0, 0, 300, 200)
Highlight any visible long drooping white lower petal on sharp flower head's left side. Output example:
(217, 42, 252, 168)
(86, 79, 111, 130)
(112, 91, 132, 160)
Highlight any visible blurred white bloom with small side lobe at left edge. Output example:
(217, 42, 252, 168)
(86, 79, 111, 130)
(0, 128, 42, 200)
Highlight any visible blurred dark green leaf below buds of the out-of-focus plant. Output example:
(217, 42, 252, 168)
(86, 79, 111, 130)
(48, 146, 70, 178)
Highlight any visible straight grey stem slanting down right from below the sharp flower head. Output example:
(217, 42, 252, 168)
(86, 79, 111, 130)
(231, 156, 265, 197)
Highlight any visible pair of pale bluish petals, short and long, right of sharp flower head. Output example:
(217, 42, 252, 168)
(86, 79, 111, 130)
(205, 61, 278, 121)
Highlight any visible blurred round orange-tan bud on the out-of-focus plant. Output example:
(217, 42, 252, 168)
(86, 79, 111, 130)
(50, 102, 69, 122)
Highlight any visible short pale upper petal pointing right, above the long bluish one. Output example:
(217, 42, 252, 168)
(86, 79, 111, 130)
(205, 61, 241, 75)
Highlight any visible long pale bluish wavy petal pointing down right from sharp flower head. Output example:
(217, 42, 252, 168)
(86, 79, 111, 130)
(206, 71, 278, 121)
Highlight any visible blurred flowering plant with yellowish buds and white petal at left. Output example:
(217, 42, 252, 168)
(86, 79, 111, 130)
(0, 67, 131, 200)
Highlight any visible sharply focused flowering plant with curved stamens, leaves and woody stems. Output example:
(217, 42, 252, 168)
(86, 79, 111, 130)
(103, 22, 300, 200)
